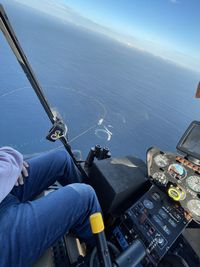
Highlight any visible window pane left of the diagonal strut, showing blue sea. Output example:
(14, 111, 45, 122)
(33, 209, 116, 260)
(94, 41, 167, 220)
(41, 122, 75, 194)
(0, 30, 60, 157)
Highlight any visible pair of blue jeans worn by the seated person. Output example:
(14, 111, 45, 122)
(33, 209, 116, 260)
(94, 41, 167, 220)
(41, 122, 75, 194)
(0, 151, 100, 267)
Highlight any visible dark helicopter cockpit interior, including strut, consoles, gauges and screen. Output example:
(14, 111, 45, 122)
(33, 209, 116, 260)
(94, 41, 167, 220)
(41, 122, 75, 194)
(0, 6, 200, 267)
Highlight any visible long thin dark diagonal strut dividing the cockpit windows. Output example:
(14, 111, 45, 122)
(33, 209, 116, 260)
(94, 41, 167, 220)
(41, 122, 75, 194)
(0, 4, 83, 173)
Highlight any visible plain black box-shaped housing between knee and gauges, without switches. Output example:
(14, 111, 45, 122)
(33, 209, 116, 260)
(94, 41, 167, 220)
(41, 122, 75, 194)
(88, 156, 150, 214)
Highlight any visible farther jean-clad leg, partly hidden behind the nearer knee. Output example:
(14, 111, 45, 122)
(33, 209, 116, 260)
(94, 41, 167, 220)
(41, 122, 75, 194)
(11, 150, 81, 202)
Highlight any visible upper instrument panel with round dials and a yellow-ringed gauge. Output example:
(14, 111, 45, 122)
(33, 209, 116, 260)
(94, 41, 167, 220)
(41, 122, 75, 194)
(147, 147, 200, 222)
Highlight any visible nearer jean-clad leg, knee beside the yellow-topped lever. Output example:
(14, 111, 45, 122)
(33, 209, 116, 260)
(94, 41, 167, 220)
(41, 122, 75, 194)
(0, 184, 100, 267)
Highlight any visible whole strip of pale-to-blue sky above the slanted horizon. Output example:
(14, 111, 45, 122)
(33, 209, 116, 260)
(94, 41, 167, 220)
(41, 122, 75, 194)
(0, 0, 200, 73)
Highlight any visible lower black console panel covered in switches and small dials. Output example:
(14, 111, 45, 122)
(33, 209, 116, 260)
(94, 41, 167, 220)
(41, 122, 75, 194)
(112, 186, 189, 266)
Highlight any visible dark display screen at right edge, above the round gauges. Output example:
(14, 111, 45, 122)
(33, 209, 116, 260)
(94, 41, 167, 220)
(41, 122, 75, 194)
(177, 121, 200, 159)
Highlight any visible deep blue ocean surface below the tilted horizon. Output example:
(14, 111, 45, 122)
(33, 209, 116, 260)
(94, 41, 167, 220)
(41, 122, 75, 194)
(0, 5, 200, 159)
